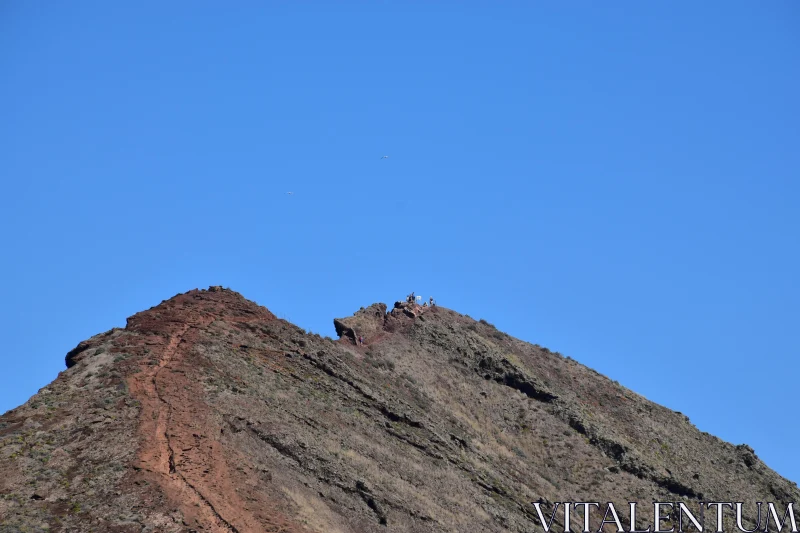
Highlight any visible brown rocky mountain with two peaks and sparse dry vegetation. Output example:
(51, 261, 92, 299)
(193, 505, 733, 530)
(0, 287, 800, 533)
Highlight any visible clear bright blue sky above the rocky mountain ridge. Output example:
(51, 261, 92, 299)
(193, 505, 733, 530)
(0, 0, 800, 482)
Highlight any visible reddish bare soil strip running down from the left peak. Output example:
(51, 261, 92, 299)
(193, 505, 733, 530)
(128, 293, 305, 533)
